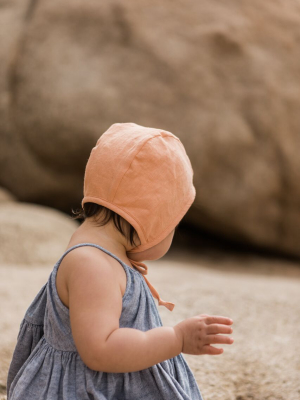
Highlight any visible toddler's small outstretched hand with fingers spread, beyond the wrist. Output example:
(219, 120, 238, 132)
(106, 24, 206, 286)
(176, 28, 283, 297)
(174, 314, 233, 355)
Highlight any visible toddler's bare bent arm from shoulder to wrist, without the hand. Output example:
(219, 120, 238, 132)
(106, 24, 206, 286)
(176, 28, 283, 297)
(64, 249, 182, 373)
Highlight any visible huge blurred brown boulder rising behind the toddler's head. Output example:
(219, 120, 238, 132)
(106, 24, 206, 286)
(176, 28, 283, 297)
(0, 0, 300, 256)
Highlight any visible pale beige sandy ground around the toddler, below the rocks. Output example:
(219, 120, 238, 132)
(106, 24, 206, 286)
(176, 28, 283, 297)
(0, 249, 300, 400)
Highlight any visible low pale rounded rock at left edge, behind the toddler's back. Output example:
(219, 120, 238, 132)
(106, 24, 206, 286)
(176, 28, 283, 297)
(0, 202, 79, 266)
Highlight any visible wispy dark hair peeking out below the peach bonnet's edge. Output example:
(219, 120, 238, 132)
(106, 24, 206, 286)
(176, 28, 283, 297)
(71, 202, 139, 246)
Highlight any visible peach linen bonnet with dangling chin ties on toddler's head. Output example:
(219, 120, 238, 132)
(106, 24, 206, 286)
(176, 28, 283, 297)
(81, 122, 196, 311)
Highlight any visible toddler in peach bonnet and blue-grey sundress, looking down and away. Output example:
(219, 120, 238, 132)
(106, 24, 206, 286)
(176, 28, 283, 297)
(7, 123, 233, 400)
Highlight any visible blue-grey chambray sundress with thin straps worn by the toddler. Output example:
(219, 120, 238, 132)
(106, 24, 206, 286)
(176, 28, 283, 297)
(7, 243, 203, 400)
